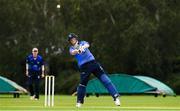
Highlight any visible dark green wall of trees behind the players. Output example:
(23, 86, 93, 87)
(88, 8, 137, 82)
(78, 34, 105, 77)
(0, 0, 180, 93)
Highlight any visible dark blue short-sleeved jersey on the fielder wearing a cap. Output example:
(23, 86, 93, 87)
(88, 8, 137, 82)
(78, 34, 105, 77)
(26, 54, 44, 72)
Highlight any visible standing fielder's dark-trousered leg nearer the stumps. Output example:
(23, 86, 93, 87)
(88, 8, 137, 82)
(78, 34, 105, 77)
(34, 76, 40, 100)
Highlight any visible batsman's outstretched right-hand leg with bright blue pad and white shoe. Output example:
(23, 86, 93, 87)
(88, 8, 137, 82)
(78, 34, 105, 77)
(93, 63, 120, 106)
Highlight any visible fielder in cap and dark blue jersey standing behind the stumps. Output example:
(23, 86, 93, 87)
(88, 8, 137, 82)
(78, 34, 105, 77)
(26, 48, 44, 100)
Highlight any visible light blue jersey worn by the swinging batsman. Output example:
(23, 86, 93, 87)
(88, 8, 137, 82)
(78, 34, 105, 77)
(69, 41, 95, 66)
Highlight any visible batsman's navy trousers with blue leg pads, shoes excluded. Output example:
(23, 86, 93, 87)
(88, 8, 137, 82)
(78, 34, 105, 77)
(77, 60, 119, 103)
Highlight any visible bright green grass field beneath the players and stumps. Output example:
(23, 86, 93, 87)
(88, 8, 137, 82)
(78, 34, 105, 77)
(0, 95, 180, 111)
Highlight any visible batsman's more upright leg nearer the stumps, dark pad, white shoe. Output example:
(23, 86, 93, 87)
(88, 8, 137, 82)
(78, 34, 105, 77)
(76, 72, 90, 107)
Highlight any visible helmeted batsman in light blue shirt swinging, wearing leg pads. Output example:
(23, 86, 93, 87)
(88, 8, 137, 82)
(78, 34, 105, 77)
(68, 33, 120, 108)
